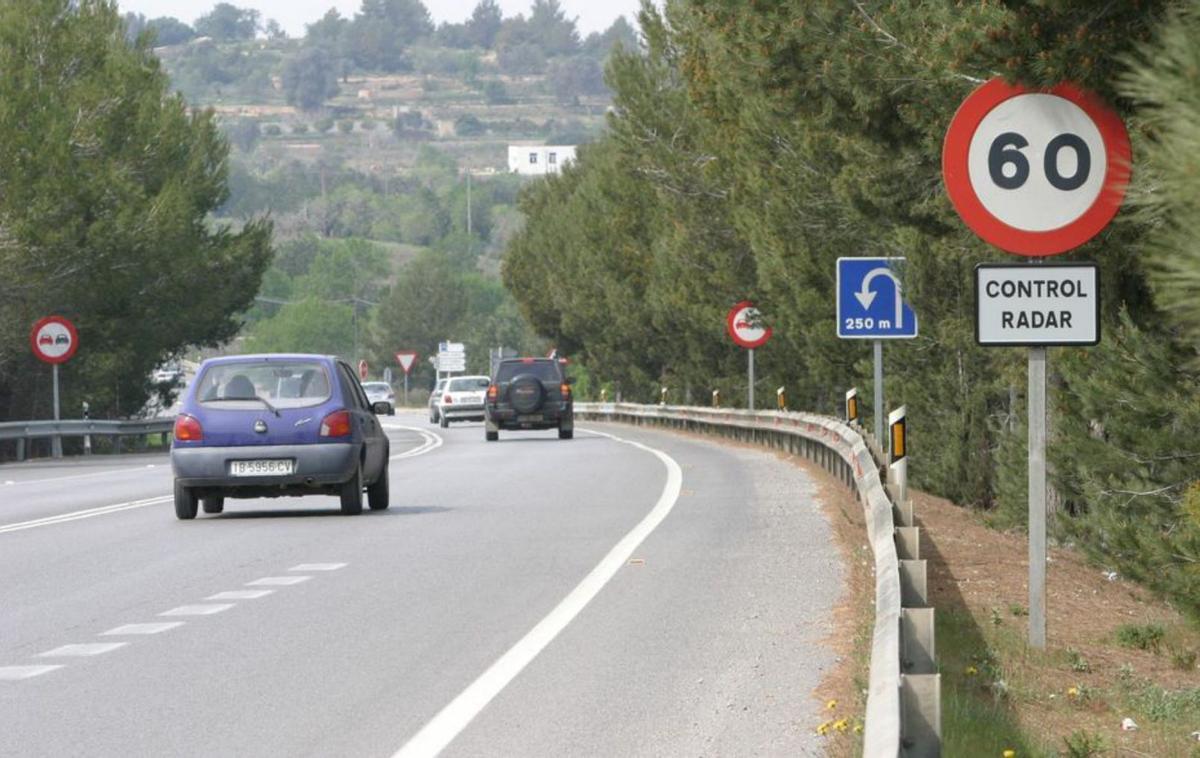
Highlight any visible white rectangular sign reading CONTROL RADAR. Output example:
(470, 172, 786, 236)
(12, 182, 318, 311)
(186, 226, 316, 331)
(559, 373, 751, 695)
(976, 263, 1100, 347)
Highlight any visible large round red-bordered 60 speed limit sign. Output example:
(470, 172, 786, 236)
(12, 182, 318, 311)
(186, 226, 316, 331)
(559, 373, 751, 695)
(942, 79, 1132, 257)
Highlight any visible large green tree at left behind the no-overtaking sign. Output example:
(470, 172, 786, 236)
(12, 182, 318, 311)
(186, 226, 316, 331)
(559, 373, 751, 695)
(0, 0, 271, 419)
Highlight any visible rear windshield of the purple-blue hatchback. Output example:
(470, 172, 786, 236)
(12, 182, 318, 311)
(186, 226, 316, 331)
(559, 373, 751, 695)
(196, 361, 331, 408)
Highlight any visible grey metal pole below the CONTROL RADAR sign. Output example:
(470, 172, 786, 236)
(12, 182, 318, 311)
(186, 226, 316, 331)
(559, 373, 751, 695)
(1030, 348, 1046, 650)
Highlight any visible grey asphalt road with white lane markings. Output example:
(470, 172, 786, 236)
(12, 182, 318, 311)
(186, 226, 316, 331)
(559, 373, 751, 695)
(0, 416, 844, 757)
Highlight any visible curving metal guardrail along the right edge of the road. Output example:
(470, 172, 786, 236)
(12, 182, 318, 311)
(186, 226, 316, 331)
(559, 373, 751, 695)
(575, 403, 942, 758)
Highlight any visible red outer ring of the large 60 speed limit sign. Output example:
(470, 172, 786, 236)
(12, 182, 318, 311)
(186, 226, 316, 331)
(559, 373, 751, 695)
(942, 78, 1133, 257)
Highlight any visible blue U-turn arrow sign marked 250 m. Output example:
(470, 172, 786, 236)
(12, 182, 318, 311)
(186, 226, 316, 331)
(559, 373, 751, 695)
(838, 258, 917, 339)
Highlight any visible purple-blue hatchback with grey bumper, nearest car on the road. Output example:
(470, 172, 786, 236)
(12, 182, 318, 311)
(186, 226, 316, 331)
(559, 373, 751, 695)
(170, 355, 389, 519)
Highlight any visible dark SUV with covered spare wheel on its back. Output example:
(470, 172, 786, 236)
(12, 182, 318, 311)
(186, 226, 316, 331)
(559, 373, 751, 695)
(484, 357, 575, 443)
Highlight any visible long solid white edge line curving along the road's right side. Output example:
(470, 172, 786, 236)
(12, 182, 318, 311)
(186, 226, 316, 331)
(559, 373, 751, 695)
(392, 432, 683, 758)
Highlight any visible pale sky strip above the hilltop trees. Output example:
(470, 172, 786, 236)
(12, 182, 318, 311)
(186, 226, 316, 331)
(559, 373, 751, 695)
(118, 0, 641, 37)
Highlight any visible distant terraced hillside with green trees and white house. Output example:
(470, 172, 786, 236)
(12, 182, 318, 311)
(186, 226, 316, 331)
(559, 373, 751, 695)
(118, 0, 638, 385)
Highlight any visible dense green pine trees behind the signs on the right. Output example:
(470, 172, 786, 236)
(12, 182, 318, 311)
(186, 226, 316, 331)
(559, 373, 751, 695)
(503, 0, 1200, 612)
